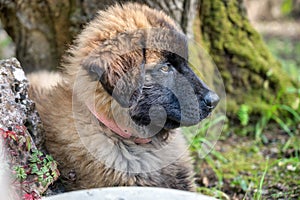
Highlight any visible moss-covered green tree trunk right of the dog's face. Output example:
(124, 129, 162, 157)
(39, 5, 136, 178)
(199, 0, 299, 115)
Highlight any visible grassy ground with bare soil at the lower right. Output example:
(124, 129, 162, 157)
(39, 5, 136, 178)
(192, 124, 300, 199)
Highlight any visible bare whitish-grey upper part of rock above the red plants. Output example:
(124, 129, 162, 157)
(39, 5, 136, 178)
(0, 58, 44, 150)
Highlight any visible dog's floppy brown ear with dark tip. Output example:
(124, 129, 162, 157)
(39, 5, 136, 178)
(82, 32, 145, 107)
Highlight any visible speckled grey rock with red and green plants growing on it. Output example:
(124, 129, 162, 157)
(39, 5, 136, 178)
(0, 58, 59, 199)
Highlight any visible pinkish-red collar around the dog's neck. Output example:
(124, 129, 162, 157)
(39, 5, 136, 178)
(86, 103, 151, 144)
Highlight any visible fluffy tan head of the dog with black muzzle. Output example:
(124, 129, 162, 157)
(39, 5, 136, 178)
(74, 4, 219, 138)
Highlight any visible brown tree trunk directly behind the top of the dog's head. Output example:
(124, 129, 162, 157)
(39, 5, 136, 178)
(0, 0, 196, 72)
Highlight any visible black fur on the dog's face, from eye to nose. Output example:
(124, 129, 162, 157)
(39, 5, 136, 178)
(130, 52, 219, 129)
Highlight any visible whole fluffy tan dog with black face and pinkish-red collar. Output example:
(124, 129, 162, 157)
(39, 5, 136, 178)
(31, 4, 219, 190)
